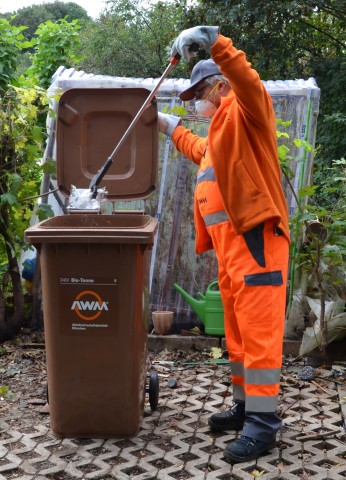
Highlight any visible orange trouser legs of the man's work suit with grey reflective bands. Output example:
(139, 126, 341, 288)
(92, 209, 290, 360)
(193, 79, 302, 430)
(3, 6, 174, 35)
(207, 221, 289, 428)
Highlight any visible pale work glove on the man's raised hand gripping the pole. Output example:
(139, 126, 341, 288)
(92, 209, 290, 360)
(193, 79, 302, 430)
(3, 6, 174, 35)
(171, 25, 219, 62)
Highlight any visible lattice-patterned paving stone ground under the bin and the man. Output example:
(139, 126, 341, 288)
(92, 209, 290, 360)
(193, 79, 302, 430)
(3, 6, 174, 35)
(0, 348, 346, 480)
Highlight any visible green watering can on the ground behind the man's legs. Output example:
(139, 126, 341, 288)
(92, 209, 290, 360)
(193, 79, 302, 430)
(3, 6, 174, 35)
(173, 280, 225, 336)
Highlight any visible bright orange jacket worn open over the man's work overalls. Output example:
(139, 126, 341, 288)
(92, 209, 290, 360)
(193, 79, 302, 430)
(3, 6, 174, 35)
(172, 34, 290, 253)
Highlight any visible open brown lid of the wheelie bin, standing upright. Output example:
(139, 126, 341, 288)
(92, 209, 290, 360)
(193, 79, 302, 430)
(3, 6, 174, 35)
(56, 88, 158, 200)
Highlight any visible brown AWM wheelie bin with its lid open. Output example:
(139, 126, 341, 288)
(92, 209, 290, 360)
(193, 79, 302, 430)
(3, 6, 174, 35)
(25, 88, 158, 438)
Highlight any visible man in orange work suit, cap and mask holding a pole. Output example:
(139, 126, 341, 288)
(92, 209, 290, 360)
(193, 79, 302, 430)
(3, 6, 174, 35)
(159, 26, 290, 463)
